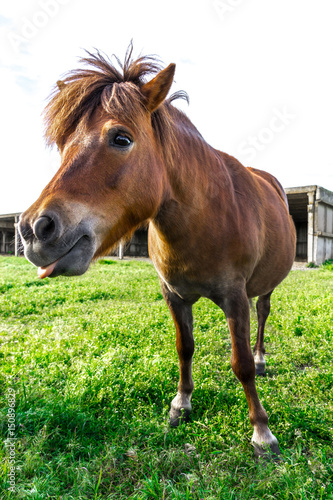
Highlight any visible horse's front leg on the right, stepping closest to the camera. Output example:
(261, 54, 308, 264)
(221, 290, 280, 456)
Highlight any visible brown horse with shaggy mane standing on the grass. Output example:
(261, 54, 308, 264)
(19, 50, 295, 454)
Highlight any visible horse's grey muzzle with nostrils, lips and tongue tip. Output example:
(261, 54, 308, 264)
(19, 207, 97, 278)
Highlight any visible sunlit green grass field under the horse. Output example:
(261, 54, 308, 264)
(0, 257, 333, 500)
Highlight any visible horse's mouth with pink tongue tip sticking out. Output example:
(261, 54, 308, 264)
(29, 236, 95, 279)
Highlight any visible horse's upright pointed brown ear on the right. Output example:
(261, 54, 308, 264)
(141, 64, 176, 113)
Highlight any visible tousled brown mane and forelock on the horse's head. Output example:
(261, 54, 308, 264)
(43, 44, 188, 147)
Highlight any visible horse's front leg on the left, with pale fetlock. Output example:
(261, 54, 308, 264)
(162, 283, 194, 427)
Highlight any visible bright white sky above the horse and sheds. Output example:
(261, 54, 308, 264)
(0, 0, 333, 214)
